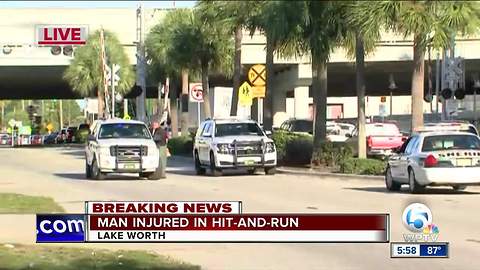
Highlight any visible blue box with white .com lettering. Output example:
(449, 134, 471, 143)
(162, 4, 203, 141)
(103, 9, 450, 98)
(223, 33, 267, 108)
(37, 214, 86, 243)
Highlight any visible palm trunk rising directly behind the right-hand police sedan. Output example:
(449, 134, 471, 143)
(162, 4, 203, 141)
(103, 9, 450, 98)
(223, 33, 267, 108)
(412, 36, 425, 131)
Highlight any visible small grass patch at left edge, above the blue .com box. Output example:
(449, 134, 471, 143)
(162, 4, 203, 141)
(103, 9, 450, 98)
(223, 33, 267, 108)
(0, 193, 65, 214)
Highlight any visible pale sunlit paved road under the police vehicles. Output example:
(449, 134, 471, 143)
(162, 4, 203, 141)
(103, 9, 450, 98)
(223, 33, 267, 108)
(0, 148, 480, 270)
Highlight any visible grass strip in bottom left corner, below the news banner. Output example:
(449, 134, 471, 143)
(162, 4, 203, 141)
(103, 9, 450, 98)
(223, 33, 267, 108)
(0, 244, 200, 270)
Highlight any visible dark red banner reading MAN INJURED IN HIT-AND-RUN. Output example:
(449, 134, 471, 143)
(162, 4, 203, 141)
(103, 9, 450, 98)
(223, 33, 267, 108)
(89, 214, 388, 231)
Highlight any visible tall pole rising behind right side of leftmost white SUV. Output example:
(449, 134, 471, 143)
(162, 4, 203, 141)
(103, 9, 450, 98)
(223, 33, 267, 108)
(136, 4, 147, 122)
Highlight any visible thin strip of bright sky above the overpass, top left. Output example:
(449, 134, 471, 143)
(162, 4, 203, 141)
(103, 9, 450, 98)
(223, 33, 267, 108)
(0, 0, 195, 8)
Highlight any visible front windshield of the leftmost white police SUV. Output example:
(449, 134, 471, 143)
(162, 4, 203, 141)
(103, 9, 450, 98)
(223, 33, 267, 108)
(98, 123, 151, 139)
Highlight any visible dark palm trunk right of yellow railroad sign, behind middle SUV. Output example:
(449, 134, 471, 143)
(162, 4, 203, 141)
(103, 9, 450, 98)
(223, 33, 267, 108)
(263, 37, 275, 130)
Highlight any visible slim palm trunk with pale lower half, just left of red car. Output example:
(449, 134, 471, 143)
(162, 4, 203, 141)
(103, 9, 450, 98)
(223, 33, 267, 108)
(355, 33, 367, 158)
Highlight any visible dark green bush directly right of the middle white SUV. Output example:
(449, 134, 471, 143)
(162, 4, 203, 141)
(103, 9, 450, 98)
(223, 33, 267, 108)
(272, 131, 313, 164)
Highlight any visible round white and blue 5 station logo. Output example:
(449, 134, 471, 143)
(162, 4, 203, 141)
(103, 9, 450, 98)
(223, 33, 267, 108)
(402, 203, 433, 232)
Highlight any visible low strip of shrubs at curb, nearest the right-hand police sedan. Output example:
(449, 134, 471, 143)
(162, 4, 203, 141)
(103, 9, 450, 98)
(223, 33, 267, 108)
(339, 157, 386, 175)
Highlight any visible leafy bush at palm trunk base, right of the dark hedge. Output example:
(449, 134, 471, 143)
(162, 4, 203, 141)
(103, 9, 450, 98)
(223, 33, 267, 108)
(312, 142, 353, 167)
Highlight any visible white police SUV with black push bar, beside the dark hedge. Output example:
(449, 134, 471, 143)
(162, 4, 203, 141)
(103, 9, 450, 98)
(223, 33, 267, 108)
(193, 119, 277, 176)
